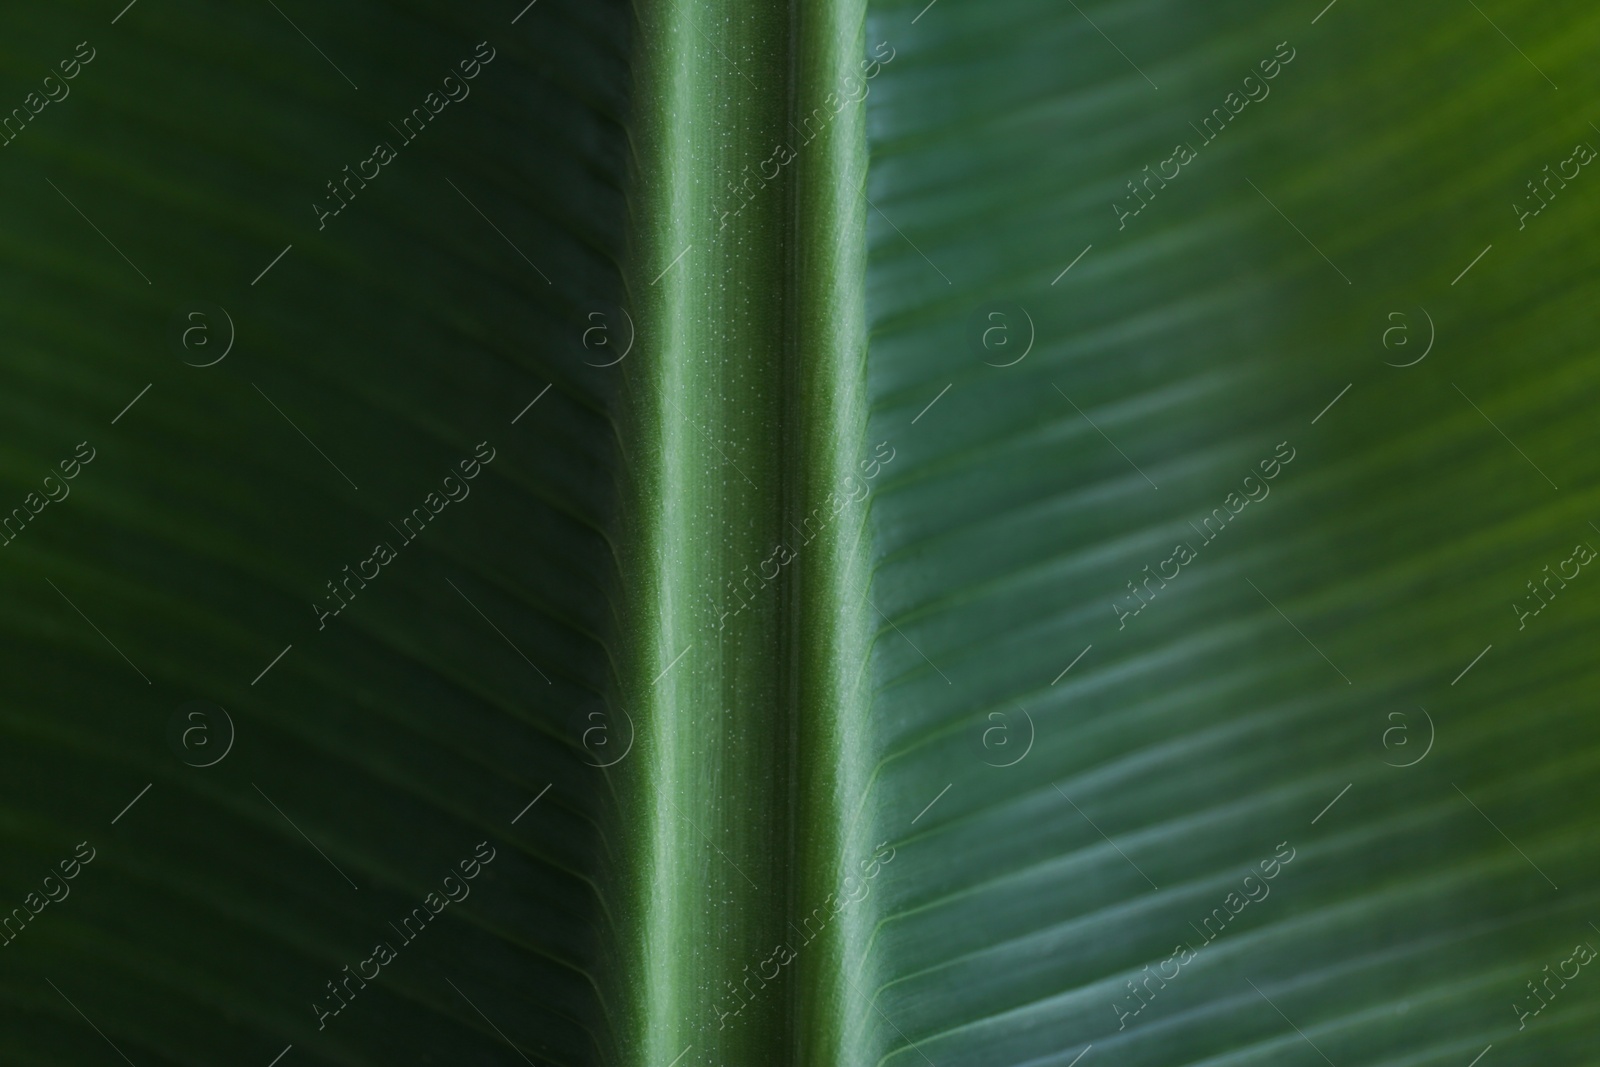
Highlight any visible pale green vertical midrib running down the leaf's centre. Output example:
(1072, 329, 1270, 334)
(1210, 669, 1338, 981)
(611, 0, 874, 1067)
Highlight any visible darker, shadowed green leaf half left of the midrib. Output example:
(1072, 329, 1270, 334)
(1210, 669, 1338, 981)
(0, 0, 630, 1067)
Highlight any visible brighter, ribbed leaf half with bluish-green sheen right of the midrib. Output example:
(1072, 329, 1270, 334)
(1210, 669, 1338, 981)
(840, 0, 1600, 1067)
